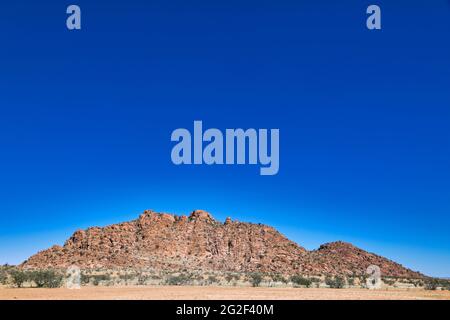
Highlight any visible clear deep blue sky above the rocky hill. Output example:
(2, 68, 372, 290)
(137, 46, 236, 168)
(0, 0, 450, 276)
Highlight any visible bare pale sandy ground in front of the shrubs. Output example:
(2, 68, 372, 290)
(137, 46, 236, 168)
(0, 286, 450, 300)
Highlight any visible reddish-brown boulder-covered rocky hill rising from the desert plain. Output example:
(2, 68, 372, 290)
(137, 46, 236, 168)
(22, 210, 423, 278)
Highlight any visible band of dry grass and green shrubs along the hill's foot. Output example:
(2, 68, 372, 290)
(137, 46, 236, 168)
(5, 265, 444, 290)
